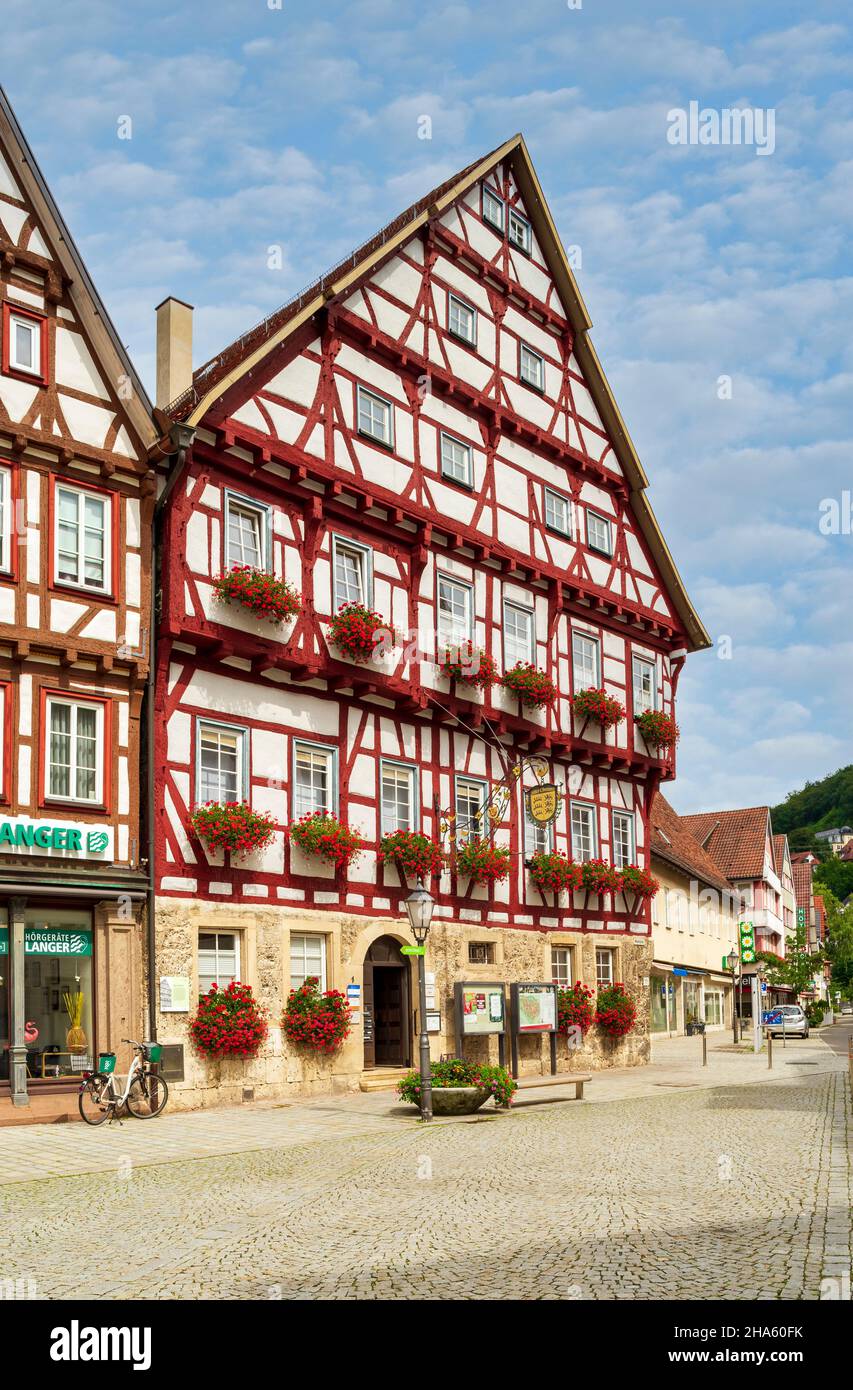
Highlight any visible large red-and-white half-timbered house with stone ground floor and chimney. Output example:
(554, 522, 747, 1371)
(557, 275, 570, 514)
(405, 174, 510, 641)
(156, 136, 709, 1104)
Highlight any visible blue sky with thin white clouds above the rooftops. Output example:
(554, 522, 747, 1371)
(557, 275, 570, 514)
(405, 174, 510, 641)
(0, 0, 853, 812)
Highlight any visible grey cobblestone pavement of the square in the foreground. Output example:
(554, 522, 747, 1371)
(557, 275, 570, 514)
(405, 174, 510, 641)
(0, 1023, 853, 1300)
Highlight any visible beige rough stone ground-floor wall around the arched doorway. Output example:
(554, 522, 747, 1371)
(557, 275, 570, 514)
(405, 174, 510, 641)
(156, 898, 652, 1109)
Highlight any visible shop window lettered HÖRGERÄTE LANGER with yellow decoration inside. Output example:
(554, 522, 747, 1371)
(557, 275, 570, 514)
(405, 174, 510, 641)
(22, 908, 96, 1081)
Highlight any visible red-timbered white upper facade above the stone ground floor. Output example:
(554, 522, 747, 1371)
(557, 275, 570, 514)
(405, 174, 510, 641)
(154, 138, 709, 934)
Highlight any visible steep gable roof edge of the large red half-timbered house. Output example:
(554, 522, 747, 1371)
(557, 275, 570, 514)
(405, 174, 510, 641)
(169, 135, 711, 651)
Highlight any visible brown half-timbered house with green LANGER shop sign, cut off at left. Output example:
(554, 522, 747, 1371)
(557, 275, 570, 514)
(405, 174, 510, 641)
(0, 92, 156, 1122)
